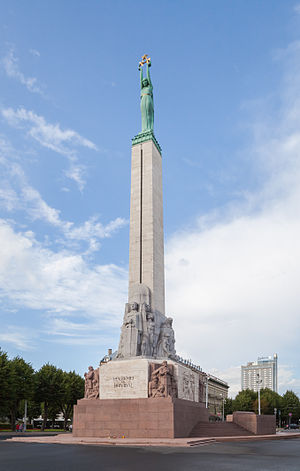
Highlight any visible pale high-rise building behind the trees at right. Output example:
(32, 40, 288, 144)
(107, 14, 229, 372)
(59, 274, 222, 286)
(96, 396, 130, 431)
(241, 353, 278, 392)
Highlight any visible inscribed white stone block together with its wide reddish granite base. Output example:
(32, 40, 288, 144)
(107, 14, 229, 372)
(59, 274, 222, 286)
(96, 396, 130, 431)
(73, 357, 209, 438)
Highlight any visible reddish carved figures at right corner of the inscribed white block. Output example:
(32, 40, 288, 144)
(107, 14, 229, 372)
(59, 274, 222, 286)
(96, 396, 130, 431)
(149, 361, 178, 398)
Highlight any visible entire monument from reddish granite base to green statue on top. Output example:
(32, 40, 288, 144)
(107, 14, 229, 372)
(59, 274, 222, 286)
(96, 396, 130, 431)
(73, 55, 208, 438)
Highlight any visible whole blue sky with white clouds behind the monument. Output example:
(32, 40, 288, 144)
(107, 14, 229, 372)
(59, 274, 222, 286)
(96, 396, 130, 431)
(0, 0, 300, 395)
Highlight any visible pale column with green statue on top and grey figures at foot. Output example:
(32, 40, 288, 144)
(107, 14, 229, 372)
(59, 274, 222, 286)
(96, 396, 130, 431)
(118, 55, 175, 358)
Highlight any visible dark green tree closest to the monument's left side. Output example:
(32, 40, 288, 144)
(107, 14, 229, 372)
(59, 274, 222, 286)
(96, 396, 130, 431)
(60, 371, 84, 430)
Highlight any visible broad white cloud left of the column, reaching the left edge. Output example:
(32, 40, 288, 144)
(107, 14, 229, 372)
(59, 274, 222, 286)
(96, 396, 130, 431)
(0, 220, 127, 327)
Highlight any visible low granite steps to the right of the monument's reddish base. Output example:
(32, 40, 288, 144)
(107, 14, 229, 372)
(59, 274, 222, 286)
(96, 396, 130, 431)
(190, 422, 254, 438)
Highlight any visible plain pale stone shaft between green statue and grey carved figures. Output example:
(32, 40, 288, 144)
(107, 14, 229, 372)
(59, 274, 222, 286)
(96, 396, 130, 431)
(128, 120, 165, 314)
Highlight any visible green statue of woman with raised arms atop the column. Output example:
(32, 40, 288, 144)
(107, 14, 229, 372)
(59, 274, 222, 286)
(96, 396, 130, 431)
(139, 59, 154, 132)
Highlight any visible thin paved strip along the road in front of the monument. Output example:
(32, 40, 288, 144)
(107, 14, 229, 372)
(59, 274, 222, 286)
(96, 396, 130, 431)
(7, 432, 300, 447)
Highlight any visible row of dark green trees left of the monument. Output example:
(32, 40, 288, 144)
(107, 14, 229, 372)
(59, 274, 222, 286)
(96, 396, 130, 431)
(0, 349, 84, 430)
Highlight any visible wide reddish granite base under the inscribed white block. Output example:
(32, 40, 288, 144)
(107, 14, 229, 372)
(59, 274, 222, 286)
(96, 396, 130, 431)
(73, 397, 209, 438)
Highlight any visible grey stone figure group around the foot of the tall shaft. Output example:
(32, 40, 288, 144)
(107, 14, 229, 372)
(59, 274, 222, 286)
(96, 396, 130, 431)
(117, 283, 176, 358)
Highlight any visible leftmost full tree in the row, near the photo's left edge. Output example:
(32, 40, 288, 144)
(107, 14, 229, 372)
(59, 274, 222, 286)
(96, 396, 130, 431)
(7, 357, 34, 431)
